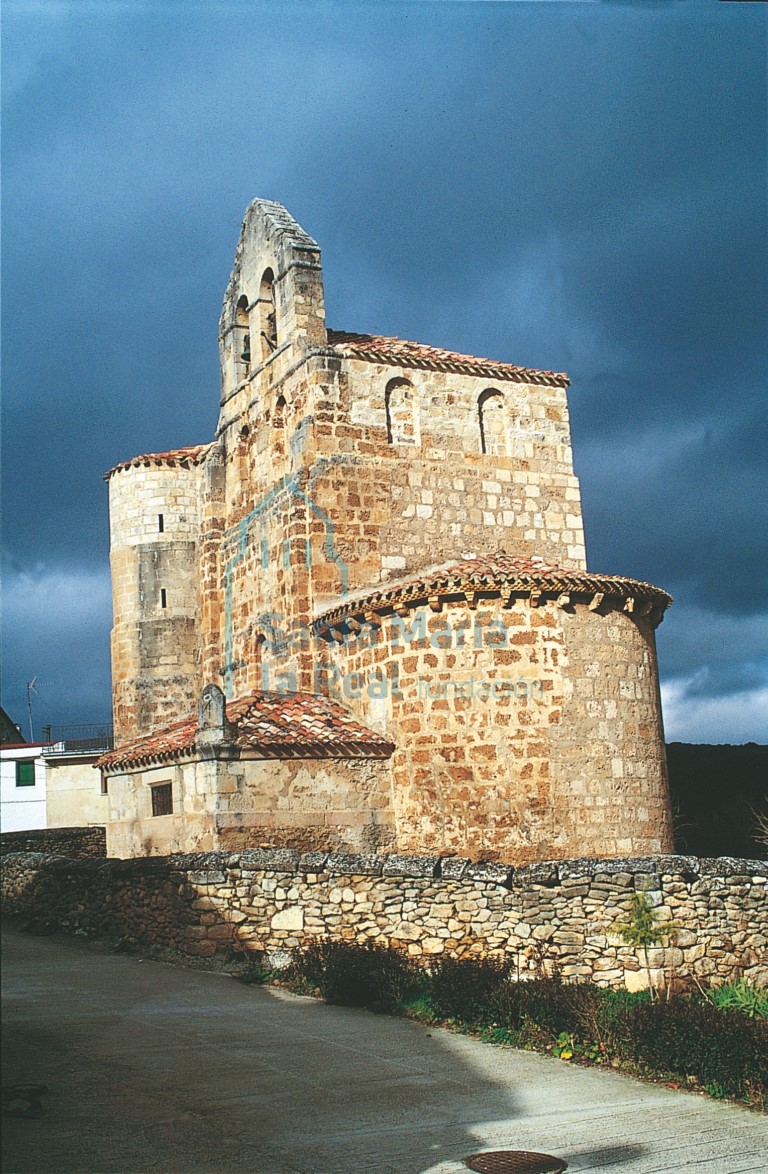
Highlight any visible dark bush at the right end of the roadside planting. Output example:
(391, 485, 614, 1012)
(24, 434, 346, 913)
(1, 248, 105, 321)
(624, 997, 768, 1101)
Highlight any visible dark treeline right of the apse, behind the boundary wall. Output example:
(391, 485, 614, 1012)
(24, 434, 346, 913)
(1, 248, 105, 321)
(667, 742, 768, 859)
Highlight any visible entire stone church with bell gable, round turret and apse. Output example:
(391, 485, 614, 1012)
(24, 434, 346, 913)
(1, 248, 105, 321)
(100, 200, 672, 864)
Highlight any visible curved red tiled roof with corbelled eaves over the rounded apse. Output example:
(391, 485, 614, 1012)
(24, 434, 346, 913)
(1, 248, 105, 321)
(317, 551, 672, 630)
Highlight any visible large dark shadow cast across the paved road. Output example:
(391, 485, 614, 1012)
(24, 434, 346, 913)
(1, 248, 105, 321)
(2, 931, 530, 1174)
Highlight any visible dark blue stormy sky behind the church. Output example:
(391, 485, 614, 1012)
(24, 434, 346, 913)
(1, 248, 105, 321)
(2, 0, 768, 742)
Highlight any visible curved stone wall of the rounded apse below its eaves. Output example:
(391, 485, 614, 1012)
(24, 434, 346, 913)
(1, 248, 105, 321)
(325, 599, 673, 864)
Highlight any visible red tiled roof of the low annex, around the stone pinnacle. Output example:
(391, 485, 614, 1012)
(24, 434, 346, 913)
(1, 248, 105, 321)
(95, 690, 395, 774)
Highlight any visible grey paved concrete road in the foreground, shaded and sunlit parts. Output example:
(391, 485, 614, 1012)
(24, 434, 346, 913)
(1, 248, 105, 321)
(2, 930, 768, 1174)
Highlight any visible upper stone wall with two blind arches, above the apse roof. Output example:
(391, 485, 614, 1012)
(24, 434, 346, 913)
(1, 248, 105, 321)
(315, 359, 586, 594)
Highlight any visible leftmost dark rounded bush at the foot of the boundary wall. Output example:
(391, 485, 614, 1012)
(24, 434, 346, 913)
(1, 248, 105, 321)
(291, 938, 416, 1011)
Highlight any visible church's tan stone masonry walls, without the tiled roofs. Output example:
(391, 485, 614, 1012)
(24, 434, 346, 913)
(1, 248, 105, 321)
(102, 200, 672, 865)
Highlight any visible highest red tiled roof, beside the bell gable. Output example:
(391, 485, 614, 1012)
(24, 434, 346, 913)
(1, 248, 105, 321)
(328, 330, 568, 387)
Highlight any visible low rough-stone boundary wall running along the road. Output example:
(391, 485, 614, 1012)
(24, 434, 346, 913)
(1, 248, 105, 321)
(2, 850, 768, 990)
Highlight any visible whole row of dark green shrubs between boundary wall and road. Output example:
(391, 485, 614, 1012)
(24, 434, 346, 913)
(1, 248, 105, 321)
(267, 938, 768, 1105)
